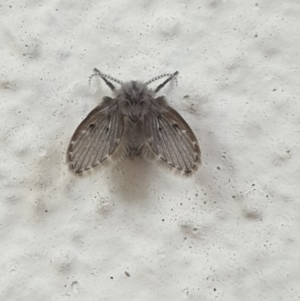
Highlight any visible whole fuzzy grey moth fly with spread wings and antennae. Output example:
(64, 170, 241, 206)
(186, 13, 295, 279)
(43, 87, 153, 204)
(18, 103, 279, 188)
(67, 68, 201, 176)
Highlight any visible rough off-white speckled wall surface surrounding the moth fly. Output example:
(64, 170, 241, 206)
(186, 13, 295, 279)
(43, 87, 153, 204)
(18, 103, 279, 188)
(0, 0, 300, 301)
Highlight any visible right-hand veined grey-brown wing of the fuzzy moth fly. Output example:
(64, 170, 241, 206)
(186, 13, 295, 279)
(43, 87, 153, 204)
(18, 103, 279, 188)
(145, 106, 201, 176)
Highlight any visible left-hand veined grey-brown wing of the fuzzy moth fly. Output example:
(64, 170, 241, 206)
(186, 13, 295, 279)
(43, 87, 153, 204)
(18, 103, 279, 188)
(67, 97, 123, 174)
